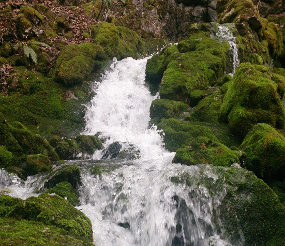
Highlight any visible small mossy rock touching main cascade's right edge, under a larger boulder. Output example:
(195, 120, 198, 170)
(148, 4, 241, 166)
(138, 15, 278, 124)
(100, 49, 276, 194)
(150, 99, 190, 124)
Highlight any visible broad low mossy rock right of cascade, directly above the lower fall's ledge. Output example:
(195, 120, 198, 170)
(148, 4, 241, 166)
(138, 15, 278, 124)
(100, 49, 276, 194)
(158, 119, 240, 166)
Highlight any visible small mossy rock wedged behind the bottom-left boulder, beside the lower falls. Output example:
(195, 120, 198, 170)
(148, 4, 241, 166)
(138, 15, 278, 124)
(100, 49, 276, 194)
(45, 181, 79, 206)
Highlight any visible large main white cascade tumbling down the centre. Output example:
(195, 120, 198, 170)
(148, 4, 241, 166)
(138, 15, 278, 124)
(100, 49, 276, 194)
(79, 58, 233, 246)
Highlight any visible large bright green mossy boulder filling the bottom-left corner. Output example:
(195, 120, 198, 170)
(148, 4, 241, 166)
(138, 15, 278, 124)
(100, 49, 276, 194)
(0, 194, 92, 245)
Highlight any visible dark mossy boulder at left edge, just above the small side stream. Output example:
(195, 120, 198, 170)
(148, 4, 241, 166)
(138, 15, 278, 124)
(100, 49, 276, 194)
(0, 113, 59, 176)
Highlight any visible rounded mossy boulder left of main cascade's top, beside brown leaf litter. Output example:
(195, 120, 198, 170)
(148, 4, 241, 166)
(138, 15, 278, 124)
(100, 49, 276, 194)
(55, 42, 104, 86)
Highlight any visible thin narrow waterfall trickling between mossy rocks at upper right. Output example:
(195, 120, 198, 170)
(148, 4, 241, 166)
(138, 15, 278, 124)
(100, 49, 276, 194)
(215, 25, 240, 76)
